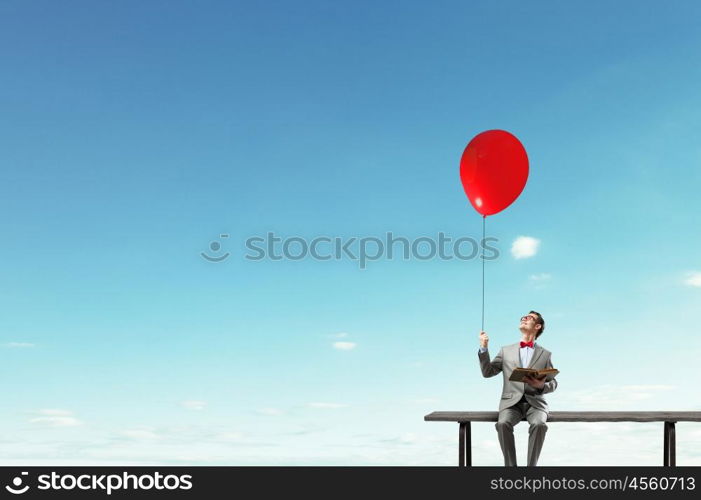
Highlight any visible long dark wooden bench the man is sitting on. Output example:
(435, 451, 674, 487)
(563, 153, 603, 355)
(424, 411, 701, 467)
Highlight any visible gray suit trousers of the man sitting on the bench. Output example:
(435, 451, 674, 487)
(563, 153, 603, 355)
(496, 398, 548, 467)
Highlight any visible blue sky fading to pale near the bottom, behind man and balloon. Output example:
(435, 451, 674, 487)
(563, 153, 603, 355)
(0, 1, 701, 465)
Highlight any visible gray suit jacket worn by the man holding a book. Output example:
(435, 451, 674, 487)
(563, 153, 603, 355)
(478, 344, 557, 413)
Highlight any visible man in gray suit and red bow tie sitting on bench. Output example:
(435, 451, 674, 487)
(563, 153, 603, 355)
(478, 311, 557, 466)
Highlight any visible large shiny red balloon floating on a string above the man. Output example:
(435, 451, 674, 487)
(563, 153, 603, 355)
(460, 130, 528, 217)
